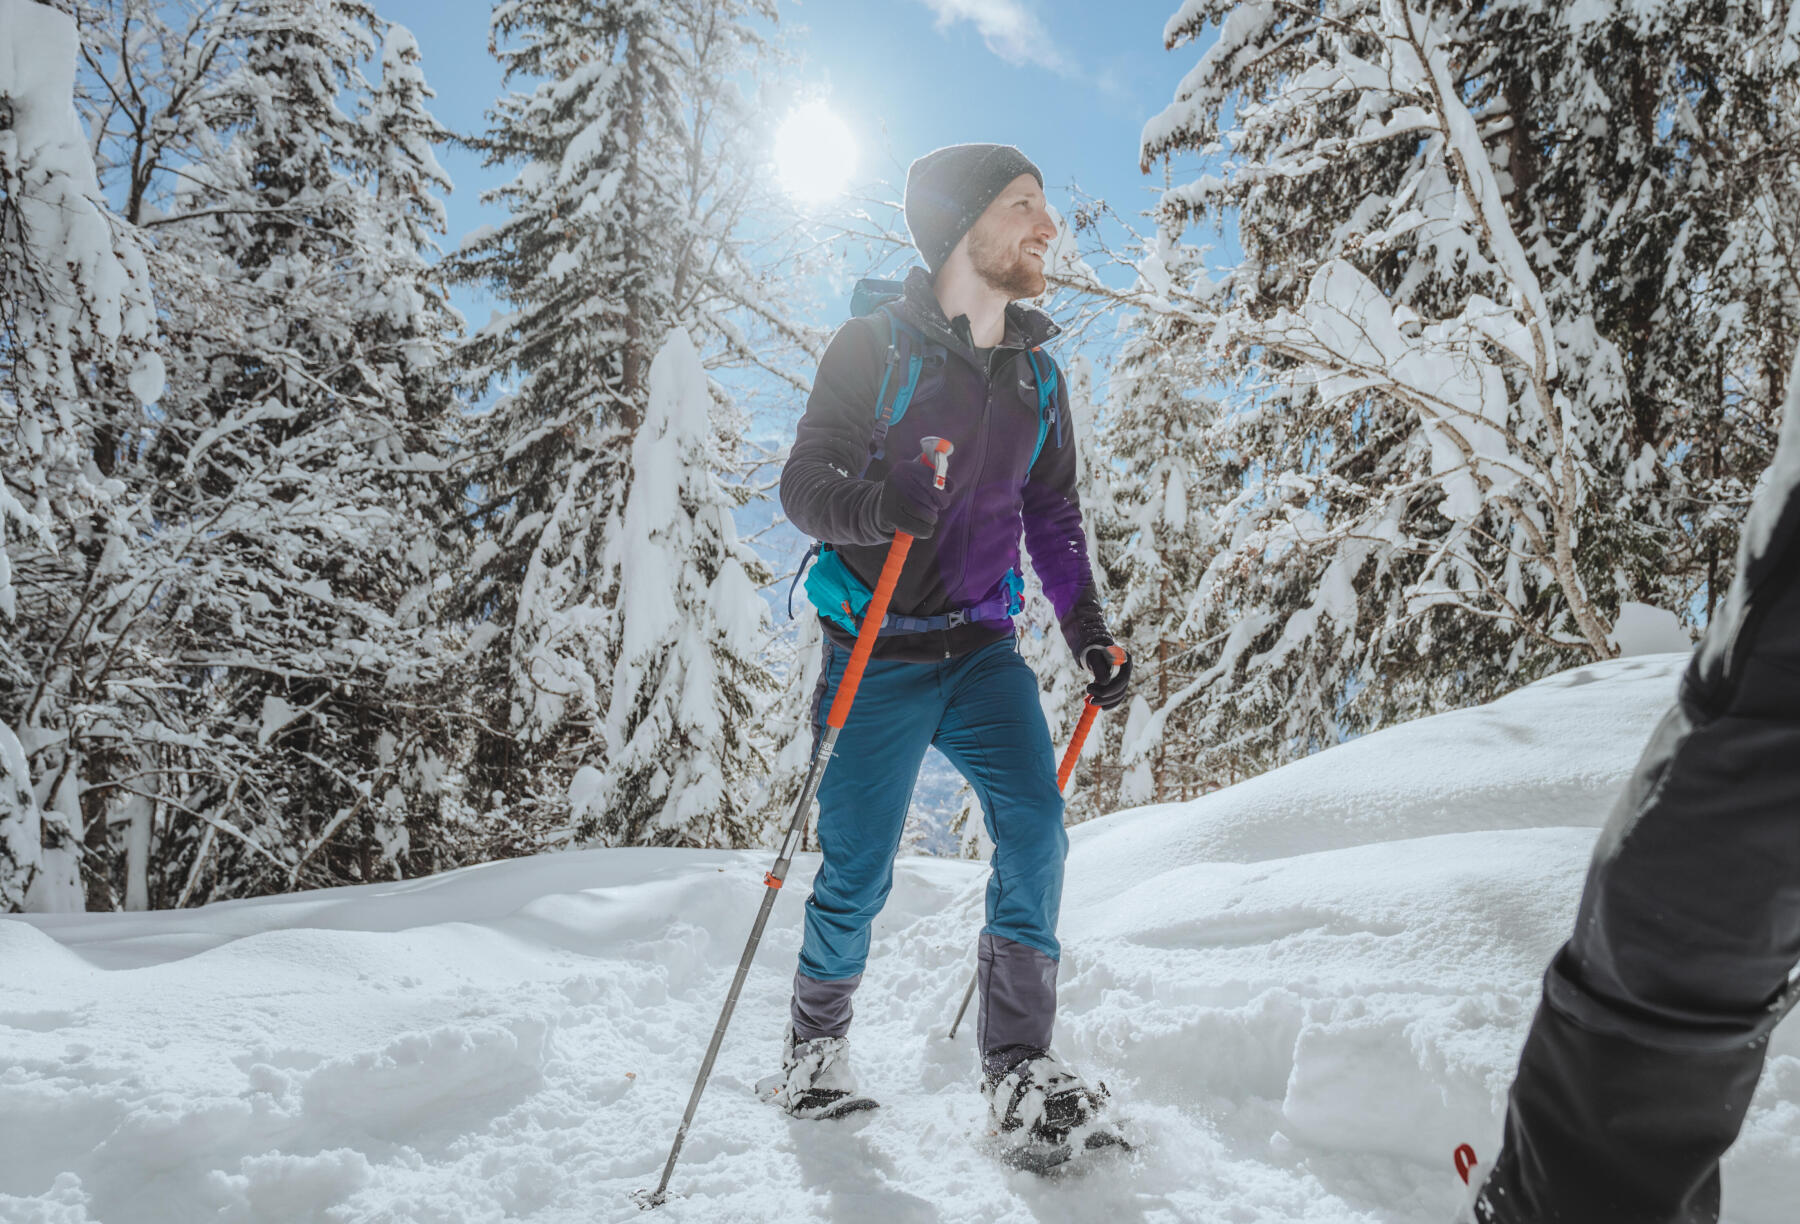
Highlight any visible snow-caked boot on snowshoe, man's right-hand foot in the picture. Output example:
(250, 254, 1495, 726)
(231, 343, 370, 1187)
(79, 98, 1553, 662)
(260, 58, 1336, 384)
(981, 1049, 1130, 1174)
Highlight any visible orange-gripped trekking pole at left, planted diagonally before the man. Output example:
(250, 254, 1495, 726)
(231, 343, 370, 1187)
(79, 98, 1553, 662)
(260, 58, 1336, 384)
(632, 437, 954, 1210)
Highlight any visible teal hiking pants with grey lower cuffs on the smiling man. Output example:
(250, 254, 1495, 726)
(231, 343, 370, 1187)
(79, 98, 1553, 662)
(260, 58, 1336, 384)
(792, 637, 1069, 1053)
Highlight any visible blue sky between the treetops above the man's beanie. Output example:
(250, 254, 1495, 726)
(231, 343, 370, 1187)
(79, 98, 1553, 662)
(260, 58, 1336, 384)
(376, 0, 1224, 326)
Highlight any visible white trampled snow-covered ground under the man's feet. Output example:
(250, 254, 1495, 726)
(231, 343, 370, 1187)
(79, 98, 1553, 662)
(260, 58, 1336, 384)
(0, 655, 1800, 1224)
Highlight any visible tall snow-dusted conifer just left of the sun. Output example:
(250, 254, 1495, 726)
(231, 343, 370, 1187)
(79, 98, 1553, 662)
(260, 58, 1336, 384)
(454, 0, 784, 842)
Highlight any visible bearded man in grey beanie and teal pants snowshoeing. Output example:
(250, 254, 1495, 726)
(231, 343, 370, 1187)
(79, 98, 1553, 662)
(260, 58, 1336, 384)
(776, 144, 1130, 1145)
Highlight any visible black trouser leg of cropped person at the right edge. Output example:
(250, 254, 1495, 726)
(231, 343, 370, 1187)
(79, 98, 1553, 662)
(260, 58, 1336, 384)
(1476, 378, 1800, 1224)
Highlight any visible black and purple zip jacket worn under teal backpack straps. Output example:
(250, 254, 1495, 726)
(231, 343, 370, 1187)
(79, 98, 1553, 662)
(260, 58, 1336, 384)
(781, 268, 1112, 662)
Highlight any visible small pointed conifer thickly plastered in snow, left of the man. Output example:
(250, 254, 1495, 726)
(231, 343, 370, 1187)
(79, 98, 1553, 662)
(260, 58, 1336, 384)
(571, 328, 774, 846)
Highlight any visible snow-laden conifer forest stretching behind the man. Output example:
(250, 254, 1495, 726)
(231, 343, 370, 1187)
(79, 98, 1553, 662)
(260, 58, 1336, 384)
(0, 0, 1800, 913)
